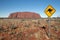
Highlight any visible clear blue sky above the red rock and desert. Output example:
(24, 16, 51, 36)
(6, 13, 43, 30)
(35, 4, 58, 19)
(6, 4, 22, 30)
(0, 0, 60, 17)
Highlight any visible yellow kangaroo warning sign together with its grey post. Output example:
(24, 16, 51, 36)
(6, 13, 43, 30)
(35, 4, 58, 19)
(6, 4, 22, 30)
(44, 5, 56, 38)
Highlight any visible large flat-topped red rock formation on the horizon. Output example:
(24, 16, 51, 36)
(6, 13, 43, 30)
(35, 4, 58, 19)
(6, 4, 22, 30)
(8, 12, 41, 18)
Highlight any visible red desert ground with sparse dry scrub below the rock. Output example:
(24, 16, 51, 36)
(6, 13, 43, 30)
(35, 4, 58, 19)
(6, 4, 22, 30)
(0, 19, 60, 40)
